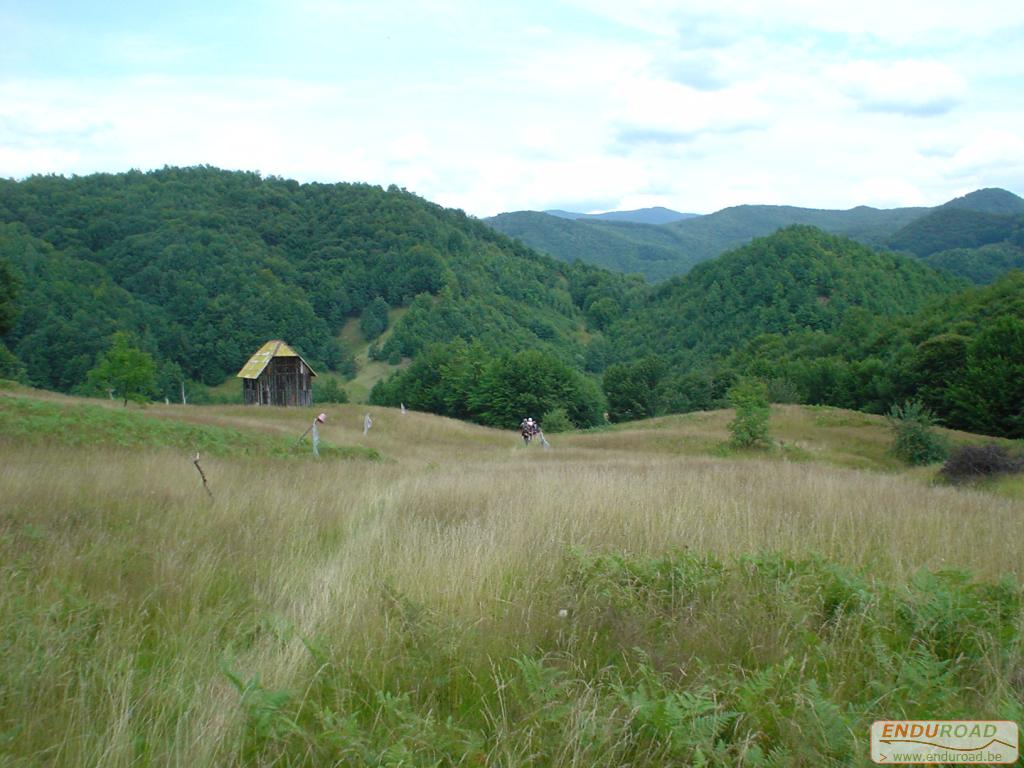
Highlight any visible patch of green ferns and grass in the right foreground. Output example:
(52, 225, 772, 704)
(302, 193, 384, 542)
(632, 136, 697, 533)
(245, 552, 1024, 766)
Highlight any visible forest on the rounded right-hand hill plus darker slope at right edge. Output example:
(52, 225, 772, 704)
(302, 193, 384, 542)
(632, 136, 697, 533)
(604, 227, 1024, 437)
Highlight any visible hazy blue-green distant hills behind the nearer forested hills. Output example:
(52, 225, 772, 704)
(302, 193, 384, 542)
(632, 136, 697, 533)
(484, 189, 1024, 283)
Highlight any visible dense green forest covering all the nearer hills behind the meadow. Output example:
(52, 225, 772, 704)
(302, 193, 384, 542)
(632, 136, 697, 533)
(0, 167, 1024, 437)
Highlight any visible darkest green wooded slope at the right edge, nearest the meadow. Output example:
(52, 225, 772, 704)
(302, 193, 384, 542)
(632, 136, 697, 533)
(719, 271, 1024, 437)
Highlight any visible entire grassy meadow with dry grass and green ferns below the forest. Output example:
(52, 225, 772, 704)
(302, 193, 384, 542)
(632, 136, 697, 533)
(0, 389, 1024, 768)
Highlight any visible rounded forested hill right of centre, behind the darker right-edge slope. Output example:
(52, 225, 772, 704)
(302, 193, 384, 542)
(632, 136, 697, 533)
(607, 225, 965, 367)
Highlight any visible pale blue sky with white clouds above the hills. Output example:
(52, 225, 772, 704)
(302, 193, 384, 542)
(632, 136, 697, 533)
(0, 0, 1024, 217)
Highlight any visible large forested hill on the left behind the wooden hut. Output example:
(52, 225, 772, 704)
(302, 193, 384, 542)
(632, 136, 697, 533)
(0, 167, 628, 397)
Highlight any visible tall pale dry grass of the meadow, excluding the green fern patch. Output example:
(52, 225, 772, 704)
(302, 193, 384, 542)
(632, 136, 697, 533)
(0, 399, 1024, 767)
